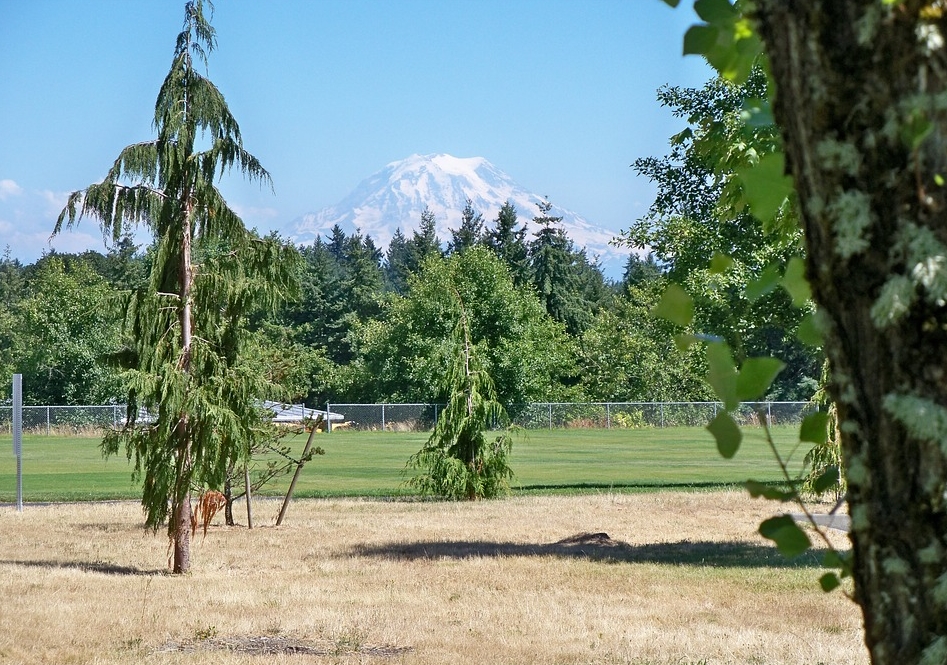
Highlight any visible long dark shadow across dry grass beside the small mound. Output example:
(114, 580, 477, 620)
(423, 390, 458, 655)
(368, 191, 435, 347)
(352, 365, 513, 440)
(346, 533, 823, 568)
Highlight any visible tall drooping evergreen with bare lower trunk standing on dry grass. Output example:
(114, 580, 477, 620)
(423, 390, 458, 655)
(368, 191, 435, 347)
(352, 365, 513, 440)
(55, 0, 298, 573)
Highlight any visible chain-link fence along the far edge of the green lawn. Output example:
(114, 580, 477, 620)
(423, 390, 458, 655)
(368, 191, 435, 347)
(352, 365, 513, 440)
(0, 402, 816, 436)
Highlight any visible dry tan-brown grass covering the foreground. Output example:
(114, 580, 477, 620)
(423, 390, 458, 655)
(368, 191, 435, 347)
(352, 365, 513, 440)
(0, 492, 867, 665)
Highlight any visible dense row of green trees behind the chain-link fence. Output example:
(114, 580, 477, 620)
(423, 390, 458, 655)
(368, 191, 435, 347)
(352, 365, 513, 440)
(0, 187, 818, 416)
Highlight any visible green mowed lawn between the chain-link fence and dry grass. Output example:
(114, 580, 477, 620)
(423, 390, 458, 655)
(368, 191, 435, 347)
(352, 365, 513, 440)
(0, 426, 808, 502)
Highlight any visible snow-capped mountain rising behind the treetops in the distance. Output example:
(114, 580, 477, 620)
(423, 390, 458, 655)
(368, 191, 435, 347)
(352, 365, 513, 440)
(287, 154, 629, 277)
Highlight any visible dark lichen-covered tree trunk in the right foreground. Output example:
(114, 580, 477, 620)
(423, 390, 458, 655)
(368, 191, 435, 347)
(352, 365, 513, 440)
(751, 0, 947, 665)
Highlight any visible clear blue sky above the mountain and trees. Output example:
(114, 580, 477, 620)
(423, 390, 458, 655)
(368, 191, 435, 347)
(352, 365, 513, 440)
(0, 0, 711, 262)
